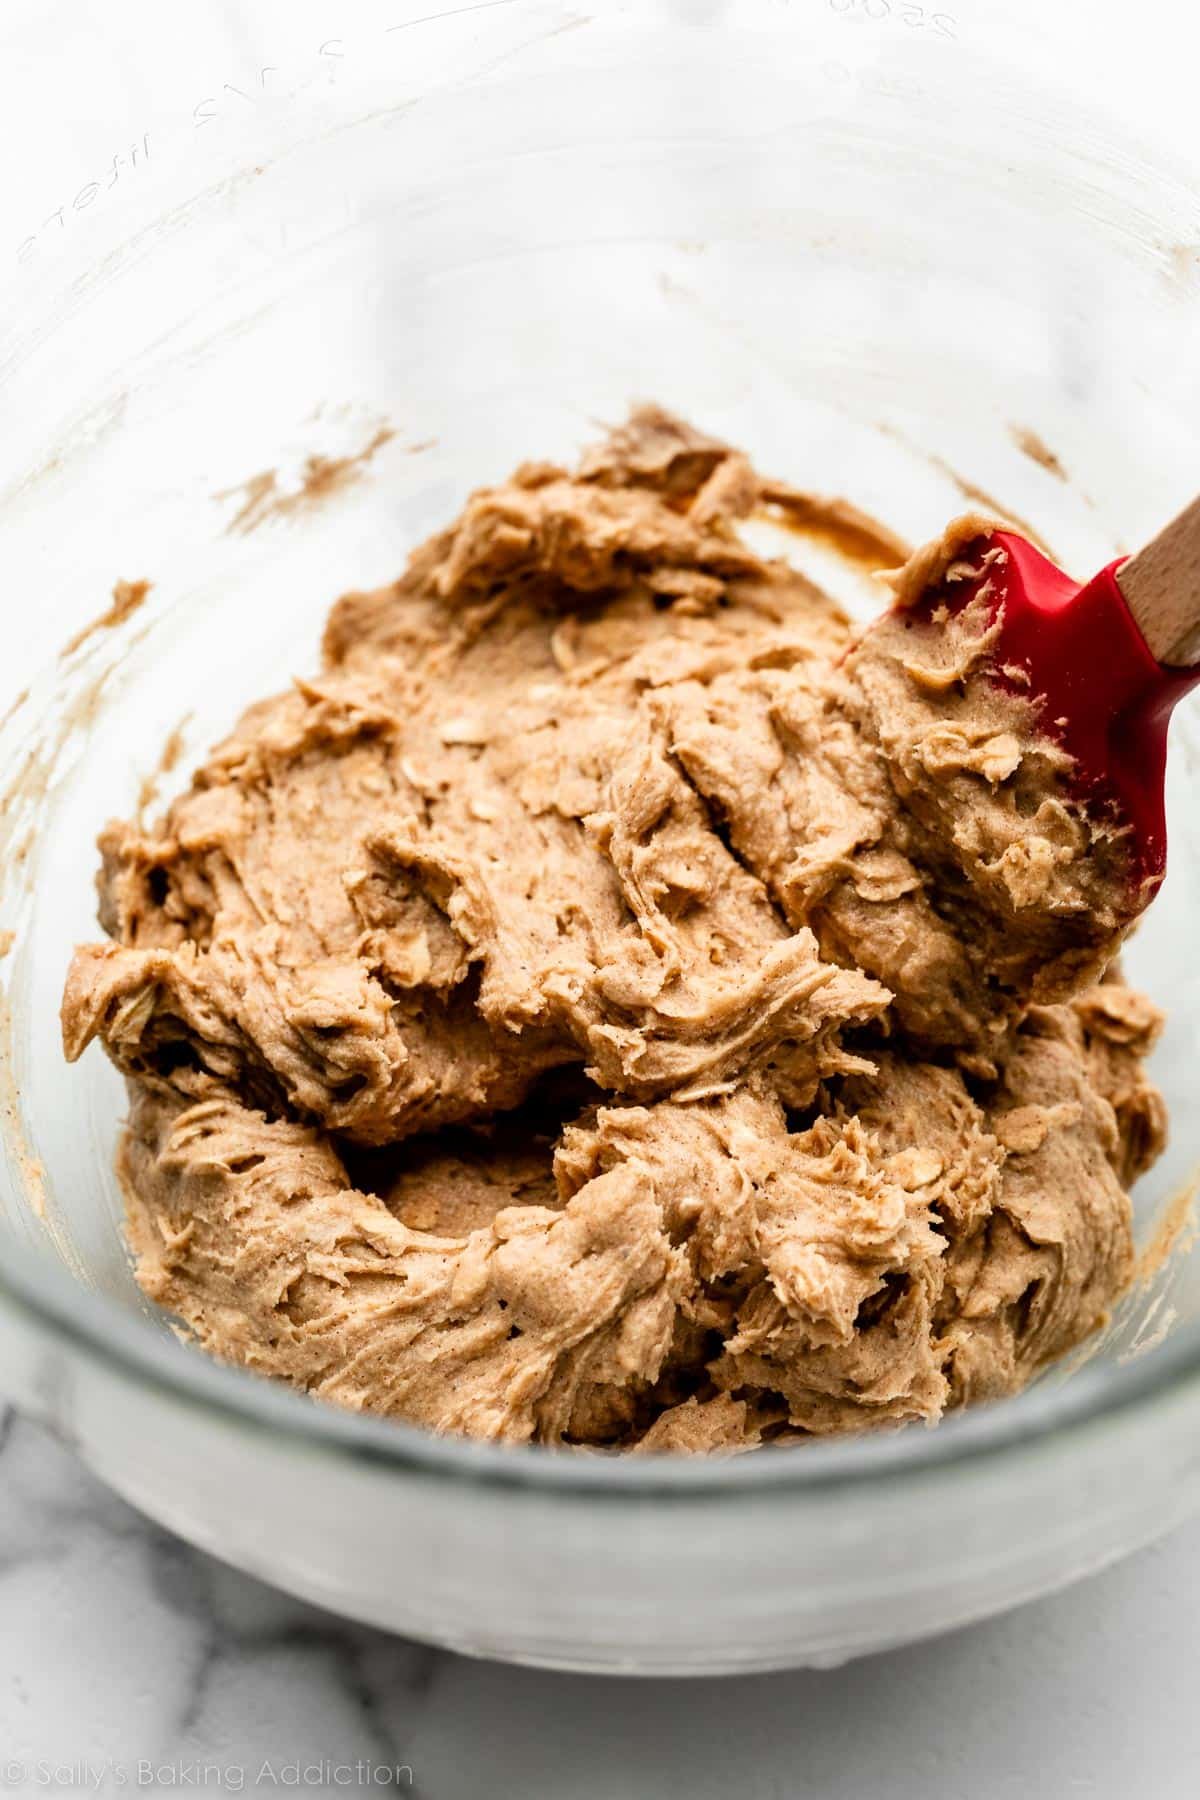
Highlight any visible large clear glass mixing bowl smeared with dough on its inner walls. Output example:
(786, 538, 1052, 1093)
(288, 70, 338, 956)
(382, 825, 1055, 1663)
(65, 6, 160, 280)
(0, 0, 1200, 1672)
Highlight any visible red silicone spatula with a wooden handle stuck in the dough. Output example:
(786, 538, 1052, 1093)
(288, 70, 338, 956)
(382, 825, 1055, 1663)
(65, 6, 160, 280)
(895, 500, 1200, 900)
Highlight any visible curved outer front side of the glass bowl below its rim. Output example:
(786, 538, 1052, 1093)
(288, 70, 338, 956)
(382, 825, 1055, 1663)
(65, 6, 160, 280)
(0, 1267, 1200, 1676)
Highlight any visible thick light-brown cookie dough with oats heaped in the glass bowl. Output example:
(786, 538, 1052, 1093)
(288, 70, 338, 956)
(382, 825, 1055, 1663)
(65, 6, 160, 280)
(63, 409, 1164, 1451)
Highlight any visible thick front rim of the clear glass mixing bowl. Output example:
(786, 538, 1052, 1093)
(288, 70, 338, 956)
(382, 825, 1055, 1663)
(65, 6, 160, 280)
(0, 1244, 1200, 1501)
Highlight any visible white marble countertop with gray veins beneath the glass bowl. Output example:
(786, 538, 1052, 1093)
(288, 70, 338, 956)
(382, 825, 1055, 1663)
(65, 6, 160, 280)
(0, 1413, 1200, 1800)
